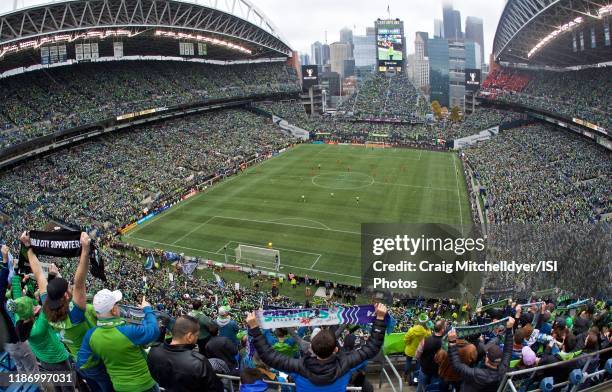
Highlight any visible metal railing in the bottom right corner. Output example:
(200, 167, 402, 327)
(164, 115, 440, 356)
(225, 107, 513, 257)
(497, 347, 612, 392)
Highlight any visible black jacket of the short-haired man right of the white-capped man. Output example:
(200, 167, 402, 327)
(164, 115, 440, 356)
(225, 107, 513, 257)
(147, 343, 223, 392)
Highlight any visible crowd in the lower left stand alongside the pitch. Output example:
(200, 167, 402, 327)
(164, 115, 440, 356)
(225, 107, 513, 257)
(0, 110, 292, 251)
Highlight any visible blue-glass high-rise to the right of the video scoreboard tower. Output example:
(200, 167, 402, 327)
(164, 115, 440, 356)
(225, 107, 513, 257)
(427, 38, 449, 107)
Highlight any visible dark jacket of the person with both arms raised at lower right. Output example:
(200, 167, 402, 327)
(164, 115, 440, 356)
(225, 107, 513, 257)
(448, 331, 513, 392)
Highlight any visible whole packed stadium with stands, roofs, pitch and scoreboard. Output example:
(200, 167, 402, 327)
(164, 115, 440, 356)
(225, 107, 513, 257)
(0, 0, 612, 392)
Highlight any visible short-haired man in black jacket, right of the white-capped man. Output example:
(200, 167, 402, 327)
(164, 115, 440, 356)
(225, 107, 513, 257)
(147, 316, 223, 392)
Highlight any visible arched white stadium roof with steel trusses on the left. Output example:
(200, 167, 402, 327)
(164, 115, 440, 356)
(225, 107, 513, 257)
(0, 0, 291, 59)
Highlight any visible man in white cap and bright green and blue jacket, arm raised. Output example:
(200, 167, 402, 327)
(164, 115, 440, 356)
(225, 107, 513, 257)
(78, 290, 159, 392)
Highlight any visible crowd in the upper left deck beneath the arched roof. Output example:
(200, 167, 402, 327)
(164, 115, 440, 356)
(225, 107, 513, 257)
(0, 61, 299, 149)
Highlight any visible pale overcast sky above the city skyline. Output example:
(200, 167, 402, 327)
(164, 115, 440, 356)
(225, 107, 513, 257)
(0, 0, 506, 62)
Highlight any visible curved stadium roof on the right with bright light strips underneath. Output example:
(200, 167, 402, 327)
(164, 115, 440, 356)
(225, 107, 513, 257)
(493, 0, 612, 67)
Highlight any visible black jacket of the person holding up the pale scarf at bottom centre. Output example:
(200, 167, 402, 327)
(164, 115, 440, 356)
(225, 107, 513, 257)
(249, 320, 386, 386)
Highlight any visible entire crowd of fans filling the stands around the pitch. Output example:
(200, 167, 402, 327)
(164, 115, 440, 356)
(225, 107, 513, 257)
(0, 62, 612, 392)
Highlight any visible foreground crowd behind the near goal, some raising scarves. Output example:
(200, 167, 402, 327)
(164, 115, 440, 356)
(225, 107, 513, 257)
(0, 239, 612, 391)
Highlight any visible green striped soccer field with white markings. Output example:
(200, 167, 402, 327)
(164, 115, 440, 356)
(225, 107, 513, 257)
(123, 144, 470, 284)
